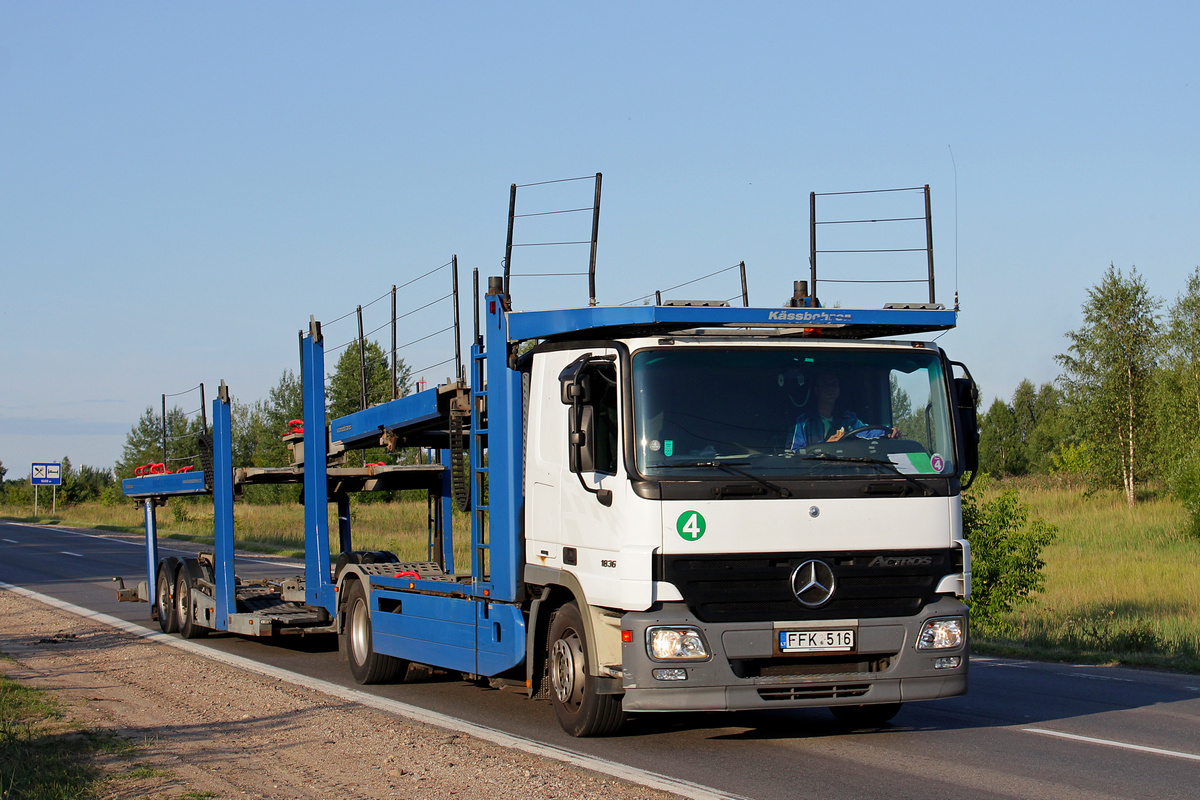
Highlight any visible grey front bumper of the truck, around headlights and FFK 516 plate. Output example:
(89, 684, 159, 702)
(622, 597, 967, 711)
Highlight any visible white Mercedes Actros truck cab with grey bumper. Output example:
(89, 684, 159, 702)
(518, 331, 971, 728)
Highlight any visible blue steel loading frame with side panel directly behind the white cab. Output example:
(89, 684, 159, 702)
(290, 316, 524, 674)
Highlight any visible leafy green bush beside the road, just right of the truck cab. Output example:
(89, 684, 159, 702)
(962, 487, 1056, 631)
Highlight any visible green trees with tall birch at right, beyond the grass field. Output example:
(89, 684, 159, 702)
(979, 264, 1200, 520)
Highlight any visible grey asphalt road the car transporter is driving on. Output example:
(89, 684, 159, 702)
(0, 523, 1200, 800)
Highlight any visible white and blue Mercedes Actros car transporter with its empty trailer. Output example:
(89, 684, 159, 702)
(125, 178, 978, 736)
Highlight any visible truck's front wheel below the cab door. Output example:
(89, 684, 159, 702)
(546, 602, 625, 736)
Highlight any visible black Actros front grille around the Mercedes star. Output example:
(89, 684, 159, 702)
(662, 549, 959, 622)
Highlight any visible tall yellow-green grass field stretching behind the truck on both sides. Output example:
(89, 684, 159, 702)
(9, 481, 1200, 672)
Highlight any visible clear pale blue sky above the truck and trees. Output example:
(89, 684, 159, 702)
(0, 0, 1200, 477)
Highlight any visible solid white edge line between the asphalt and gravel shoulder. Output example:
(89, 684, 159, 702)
(0, 581, 748, 800)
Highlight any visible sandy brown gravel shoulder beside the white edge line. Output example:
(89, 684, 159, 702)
(0, 590, 676, 800)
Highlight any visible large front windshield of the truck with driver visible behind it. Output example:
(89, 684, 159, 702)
(634, 347, 955, 480)
